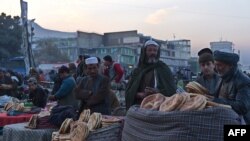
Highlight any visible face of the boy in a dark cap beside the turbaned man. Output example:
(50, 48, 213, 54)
(200, 61, 215, 76)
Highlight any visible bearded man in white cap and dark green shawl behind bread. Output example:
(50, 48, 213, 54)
(125, 40, 176, 110)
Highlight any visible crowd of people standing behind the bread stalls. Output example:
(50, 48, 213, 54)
(0, 40, 250, 124)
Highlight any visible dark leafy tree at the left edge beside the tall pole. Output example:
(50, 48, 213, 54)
(0, 13, 22, 59)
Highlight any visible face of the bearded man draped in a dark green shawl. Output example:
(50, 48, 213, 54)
(146, 45, 158, 63)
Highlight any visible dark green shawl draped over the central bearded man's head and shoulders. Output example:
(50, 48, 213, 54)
(125, 47, 176, 110)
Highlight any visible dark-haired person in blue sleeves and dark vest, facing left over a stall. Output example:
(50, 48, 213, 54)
(49, 66, 78, 109)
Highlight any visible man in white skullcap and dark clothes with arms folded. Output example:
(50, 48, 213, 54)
(75, 57, 111, 115)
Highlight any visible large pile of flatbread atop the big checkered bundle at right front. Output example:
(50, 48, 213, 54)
(140, 93, 231, 112)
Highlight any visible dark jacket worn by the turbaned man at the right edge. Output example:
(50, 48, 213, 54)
(214, 67, 250, 124)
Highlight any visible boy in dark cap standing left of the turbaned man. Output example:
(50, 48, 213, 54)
(196, 48, 220, 96)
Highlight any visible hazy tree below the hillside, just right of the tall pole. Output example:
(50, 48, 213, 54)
(34, 39, 69, 64)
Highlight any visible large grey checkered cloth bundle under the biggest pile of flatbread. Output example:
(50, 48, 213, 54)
(122, 105, 242, 141)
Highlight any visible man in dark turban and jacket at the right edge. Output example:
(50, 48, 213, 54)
(214, 51, 250, 124)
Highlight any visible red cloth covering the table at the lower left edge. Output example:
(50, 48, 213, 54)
(0, 113, 32, 127)
